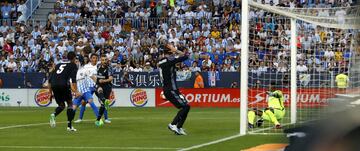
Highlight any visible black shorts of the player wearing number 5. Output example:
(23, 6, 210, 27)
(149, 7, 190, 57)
(51, 86, 72, 105)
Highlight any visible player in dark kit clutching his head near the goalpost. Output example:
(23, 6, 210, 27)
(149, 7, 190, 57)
(159, 43, 190, 135)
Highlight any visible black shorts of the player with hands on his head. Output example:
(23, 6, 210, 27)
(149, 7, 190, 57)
(164, 90, 188, 108)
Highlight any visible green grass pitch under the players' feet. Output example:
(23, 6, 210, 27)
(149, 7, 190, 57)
(0, 107, 287, 151)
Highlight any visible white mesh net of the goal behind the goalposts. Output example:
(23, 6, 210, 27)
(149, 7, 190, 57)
(248, 3, 359, 133)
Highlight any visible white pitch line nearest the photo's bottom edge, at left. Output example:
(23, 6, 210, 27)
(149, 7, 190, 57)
(0, 146, 179, 150)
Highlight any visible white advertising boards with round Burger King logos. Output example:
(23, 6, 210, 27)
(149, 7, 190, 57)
(0, 88, 155, 107)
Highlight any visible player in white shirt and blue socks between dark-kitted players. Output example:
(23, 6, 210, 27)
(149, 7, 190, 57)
(73, 54, 99, 117)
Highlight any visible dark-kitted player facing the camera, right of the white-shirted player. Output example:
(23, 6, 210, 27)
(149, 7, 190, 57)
(95, 55, 114, 126)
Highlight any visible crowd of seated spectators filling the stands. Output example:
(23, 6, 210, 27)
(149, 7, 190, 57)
(0, 0, 356, 73)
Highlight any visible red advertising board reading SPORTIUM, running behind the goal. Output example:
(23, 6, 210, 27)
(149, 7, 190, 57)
(155, 88, 335, 107)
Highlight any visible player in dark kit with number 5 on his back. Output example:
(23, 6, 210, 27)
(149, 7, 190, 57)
(48, 52, 81, 131)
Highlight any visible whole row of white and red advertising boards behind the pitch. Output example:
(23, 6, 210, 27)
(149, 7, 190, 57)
(0, 88, 336, 108)
